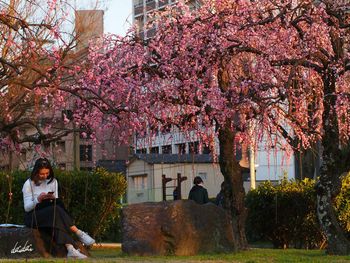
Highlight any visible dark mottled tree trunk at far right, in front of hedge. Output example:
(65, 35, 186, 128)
(316, 71, 350, 255)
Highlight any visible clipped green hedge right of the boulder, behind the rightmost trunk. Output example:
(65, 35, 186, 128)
(246, 173, 350, 249)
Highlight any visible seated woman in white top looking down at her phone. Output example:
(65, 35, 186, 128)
(22, 158, 95, 259)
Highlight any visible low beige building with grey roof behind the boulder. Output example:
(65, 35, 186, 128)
(127, 154, 223, 203)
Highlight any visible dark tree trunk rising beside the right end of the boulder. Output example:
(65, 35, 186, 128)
(219, 124, 248, 250)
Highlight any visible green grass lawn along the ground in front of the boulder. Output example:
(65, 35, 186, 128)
(0, 248, 350, 263)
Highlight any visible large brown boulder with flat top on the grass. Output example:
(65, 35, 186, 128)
(122, 200, 234, 256)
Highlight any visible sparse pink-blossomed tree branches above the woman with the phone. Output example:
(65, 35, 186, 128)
(0, 0, 98, 148)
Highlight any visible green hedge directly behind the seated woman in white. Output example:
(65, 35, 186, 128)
(0, 168, 126, 242)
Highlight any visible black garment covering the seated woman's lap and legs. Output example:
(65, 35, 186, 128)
(24, 205, 74, 245)
